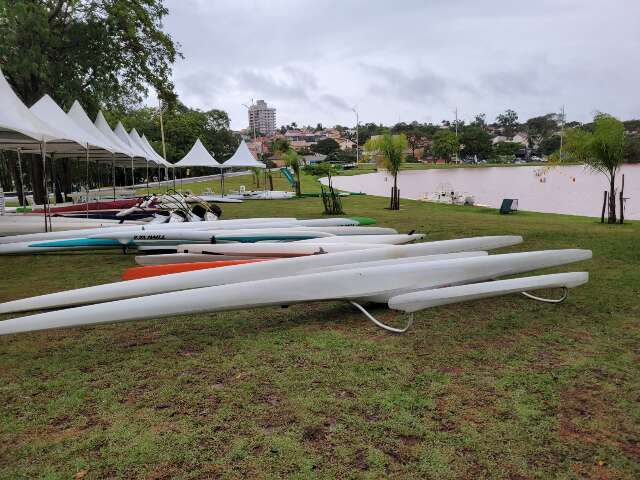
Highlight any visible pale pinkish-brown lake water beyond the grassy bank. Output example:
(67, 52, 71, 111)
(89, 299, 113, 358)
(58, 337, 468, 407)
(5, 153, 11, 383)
(323, 165, 640, 220)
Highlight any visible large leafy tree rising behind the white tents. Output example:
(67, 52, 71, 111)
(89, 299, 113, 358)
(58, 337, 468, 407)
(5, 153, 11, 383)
(0, 0, 180, 202)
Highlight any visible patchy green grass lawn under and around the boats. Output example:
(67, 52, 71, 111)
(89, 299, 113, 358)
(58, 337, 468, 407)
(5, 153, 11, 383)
(0, 179, 640, 479)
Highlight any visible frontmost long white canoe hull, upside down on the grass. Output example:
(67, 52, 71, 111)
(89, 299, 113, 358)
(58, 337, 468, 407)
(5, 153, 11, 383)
(0, 249, 591, 335)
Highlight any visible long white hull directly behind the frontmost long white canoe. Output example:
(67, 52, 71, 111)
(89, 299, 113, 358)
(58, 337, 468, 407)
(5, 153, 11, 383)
(0, 235, 522, 314)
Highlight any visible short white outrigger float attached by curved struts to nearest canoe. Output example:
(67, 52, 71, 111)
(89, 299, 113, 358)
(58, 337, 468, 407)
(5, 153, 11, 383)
(389, 272, 589, 313)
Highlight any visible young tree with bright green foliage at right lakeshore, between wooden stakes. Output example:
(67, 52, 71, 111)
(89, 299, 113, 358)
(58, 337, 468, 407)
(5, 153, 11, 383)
(565, 113, 625, 223)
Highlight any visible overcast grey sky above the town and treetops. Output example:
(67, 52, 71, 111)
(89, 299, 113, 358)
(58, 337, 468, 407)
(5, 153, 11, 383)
(160, 0, 640, 129)
